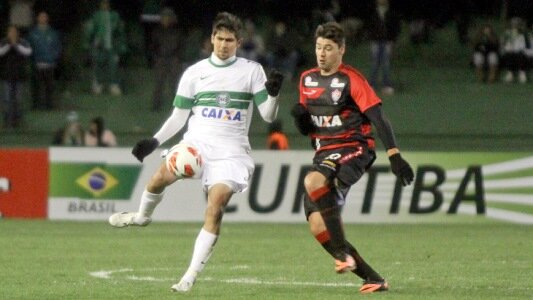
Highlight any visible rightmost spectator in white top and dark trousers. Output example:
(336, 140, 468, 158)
(501, 17, 530, 83)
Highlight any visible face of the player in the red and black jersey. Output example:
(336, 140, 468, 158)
(315, 37, 344, 75)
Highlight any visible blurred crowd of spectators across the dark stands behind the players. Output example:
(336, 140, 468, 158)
(0, 0, 533, 128)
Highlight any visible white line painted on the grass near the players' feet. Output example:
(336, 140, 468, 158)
(89, 269, 358, 287)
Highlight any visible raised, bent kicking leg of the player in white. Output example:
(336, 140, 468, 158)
(109, 163, 177, 227)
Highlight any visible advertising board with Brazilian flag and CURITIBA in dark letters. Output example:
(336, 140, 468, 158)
(48, 148, 533, 223)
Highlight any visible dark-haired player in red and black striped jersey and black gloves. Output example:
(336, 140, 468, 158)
(291, 22, 414, 293)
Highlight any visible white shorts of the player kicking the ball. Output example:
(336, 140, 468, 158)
(180, 140, 255, 193)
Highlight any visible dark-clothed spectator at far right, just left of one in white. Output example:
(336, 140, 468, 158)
(472, 25, 500, 83)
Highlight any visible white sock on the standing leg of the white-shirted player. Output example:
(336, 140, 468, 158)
(182, 228, 218, 281)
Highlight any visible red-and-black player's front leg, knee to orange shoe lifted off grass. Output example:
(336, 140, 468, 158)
(304, 171, 355, 273)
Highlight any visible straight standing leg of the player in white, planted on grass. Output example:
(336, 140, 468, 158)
(171, 183, 234, 292)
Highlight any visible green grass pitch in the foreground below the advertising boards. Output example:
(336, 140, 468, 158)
(0, 218, 533, 299)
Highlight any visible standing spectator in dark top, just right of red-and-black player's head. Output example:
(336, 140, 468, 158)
(368, 0, 400, 95)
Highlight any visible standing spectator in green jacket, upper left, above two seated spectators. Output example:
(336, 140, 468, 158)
(84, 0, 127, 96)
